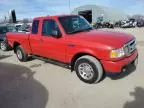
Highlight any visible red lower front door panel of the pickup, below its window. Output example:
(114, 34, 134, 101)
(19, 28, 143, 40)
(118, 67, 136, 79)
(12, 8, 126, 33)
(41, 37, 67, 63)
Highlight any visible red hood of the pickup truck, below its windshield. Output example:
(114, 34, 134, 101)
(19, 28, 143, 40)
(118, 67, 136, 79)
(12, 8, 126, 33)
(69, 30, 134, 48)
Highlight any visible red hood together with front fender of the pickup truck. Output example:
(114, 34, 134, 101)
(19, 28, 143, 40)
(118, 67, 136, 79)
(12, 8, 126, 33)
(67, 30, 134, 62)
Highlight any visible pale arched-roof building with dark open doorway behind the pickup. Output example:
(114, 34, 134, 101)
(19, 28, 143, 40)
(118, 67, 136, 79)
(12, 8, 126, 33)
(72, 5, 127, 23)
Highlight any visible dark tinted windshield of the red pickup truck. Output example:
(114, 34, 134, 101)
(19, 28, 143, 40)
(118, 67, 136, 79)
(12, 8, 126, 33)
(59, 16, 92, 34)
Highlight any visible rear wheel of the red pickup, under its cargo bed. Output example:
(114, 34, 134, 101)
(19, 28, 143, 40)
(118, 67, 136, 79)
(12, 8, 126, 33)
(16, 46, 28, 62)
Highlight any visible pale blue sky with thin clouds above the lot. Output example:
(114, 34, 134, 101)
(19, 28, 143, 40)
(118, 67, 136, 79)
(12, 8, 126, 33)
(0, 0, 144, 19)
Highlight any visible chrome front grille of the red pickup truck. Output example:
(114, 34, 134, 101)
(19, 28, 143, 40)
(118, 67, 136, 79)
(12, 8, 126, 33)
(125, 39, 136, 56)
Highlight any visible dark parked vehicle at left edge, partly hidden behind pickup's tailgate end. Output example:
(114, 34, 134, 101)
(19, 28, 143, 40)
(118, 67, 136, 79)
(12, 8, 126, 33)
(0, 25, 15, 51)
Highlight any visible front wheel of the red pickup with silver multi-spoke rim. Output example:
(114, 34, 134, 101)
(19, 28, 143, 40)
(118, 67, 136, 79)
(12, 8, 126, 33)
(74, 55, 104, 84)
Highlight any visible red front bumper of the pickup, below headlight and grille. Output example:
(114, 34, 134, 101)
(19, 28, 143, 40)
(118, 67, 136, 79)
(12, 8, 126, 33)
(101, 50, 138, 74)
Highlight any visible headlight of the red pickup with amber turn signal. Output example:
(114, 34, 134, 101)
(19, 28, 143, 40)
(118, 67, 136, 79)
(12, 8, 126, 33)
(110, 47, 125, 58)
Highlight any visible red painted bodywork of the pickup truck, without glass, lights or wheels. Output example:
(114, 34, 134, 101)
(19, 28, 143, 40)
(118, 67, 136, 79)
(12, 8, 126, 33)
(7, 16, 137, 72)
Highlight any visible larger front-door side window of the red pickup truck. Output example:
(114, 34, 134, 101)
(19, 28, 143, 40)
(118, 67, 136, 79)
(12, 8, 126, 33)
(42, 19, 60, 36)
